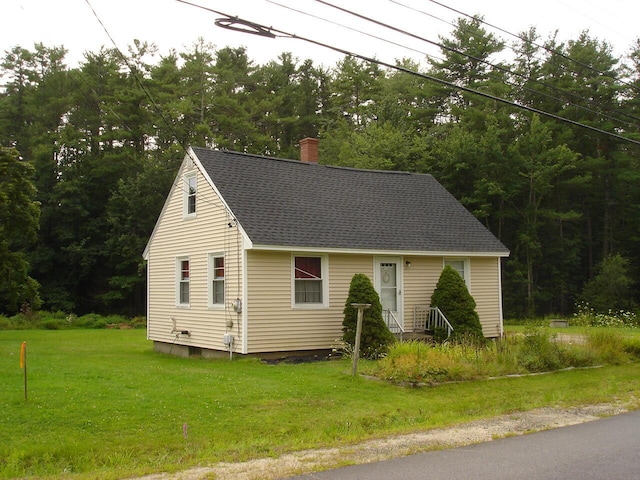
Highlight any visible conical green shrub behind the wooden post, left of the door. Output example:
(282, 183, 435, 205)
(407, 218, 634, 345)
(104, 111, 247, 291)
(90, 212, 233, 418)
(342, 273, 395, 358)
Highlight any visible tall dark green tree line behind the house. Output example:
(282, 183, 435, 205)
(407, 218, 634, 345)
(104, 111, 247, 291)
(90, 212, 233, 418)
(0, 18, 640, 317)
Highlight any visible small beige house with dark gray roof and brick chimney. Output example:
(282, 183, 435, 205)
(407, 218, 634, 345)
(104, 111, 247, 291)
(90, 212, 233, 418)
(144, 139, 509, 356)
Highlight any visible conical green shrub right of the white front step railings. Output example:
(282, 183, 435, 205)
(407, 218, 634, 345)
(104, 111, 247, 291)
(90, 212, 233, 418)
(431, 265, 484, 340)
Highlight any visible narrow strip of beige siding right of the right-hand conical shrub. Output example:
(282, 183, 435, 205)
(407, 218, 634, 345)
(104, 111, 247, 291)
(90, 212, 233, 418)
(470, 257, 502, 337)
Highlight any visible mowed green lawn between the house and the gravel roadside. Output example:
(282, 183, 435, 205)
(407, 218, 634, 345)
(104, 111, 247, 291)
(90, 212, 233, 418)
(0, 330, 640, 479)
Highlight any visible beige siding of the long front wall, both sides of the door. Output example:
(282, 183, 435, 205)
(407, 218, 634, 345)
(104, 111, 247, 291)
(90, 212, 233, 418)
(246, 250, 501, 353)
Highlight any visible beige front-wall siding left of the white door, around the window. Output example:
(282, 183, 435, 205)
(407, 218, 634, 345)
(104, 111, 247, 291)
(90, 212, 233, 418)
(246, 250, 373, 353)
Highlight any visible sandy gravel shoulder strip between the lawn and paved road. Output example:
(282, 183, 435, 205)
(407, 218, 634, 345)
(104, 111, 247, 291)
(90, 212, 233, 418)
(131, 403, 631, 480)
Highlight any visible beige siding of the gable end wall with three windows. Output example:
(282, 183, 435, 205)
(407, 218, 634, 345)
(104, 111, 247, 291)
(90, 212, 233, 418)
(148, 162, 242, 351)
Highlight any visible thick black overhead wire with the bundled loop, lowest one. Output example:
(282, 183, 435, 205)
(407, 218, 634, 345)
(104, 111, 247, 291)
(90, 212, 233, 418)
(184, 0, 640, 145)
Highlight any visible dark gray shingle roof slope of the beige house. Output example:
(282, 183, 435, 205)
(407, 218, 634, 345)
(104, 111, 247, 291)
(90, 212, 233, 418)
(193, 147, 508, 254)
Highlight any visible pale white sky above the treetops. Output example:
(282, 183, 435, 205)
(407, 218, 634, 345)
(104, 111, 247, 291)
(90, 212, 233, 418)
(0, 0, 640, 67)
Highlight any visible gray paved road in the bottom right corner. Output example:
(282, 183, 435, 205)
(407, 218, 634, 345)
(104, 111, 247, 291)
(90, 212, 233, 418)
(290, 411, 640, 480)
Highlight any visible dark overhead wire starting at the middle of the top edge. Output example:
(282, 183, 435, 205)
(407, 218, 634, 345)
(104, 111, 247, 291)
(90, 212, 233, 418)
(315, 0, 640, 128)
